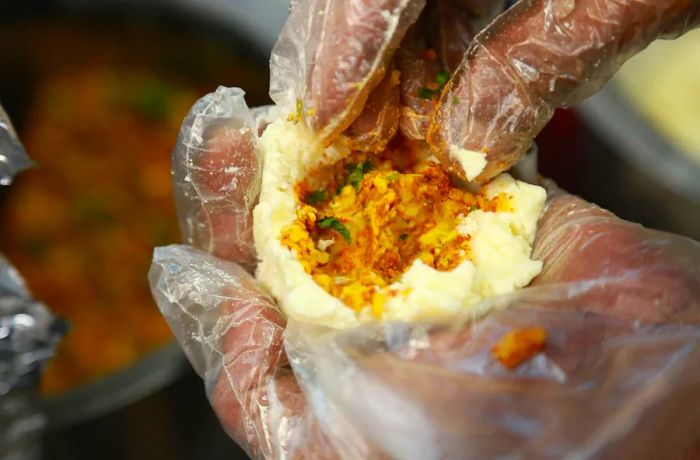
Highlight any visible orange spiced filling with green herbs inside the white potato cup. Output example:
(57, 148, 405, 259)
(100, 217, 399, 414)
(280, 141, 510, 316)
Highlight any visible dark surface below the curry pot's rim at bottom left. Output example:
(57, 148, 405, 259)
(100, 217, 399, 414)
(43, 369, 248, 460)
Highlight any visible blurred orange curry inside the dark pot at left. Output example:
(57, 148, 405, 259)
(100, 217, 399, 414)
(0, 17, 266, 393)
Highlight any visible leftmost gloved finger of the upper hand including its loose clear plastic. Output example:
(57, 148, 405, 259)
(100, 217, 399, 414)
(270, 0, 425, 144)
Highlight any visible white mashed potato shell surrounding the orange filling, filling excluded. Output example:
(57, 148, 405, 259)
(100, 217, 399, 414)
(254, 119, 546, 328)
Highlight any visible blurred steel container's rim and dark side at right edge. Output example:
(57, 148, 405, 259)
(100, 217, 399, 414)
(577, 82, 700, 240)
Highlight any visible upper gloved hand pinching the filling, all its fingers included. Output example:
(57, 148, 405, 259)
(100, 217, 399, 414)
(271, 0, 700, 182)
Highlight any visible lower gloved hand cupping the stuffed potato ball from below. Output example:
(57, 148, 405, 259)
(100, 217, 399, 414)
(150, 88, 700, 459)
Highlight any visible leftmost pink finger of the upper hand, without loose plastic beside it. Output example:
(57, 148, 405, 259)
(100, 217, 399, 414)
(303, 0, 425, 140)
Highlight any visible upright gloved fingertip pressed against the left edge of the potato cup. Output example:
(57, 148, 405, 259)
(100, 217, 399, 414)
(173, 88, 267, 270)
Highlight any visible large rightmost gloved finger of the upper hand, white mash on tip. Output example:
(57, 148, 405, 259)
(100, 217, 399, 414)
(428, 0, 700, 182)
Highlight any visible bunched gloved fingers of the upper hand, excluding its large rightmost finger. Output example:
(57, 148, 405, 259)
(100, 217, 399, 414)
(270, 0, 504, 151)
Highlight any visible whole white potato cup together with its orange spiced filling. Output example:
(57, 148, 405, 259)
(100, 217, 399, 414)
(254, 120, 546, 328)
